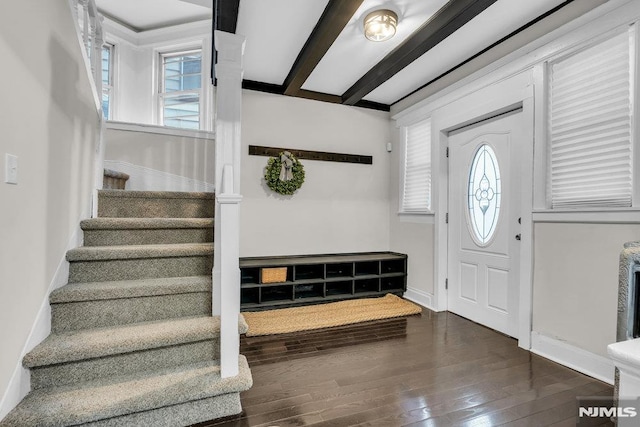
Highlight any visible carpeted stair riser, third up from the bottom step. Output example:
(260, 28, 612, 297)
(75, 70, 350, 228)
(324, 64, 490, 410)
(51, 292, 211, 333)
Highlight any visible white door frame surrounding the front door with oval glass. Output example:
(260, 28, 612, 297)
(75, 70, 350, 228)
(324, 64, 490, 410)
(431, 72, 535, 350)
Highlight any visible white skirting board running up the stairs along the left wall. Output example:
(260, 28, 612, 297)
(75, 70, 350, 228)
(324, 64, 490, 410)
(0, 227, 82, 420)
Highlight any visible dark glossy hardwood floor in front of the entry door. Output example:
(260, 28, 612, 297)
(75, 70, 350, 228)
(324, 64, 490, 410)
(198, 310, 613, 427)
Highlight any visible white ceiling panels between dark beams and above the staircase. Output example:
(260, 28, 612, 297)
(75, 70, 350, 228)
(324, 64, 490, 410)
(97, 0, 596, 105)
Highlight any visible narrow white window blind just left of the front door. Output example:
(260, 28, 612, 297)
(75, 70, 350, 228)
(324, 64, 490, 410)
(401, 120, 431, 213)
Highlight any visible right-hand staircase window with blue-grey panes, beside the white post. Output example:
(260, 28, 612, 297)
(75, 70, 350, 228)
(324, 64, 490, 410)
(160, 51, 202, 129)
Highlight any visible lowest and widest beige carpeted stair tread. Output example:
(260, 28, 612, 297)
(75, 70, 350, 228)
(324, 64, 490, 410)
(2, 355, 253, 427)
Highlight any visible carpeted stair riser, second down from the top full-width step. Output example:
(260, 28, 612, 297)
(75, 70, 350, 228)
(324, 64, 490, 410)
(84, 228, 213, 246)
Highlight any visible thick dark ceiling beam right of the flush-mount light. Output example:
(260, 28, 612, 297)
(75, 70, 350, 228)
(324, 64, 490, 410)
(342, 0, 497, 105)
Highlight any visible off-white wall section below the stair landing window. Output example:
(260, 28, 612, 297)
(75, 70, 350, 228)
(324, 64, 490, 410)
(104, 122, 215, 191)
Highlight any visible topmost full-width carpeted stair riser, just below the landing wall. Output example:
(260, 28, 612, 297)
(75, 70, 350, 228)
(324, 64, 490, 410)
(98, 195, 214, 218)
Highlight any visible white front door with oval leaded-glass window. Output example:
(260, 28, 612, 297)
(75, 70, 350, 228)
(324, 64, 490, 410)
(448, 110, 528, 337)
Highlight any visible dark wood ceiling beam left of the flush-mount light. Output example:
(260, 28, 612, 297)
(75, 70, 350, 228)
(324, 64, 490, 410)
(284, 0, 363, 96)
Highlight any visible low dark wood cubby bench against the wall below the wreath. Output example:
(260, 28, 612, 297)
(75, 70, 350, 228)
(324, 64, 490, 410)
(240, 252, 407, 311)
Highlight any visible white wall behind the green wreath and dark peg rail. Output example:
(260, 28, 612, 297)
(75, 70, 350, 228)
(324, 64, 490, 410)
(240, 91, 391, 256)
